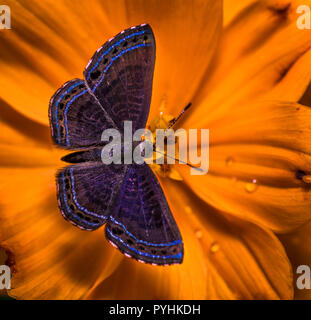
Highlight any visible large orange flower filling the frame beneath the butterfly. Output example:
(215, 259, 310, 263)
(0, 0, 311, 299)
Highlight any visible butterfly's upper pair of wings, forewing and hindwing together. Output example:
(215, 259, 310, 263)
(49, 25, 155, 149)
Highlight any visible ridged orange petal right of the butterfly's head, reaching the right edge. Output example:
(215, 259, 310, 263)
(180, 101, 311, 232)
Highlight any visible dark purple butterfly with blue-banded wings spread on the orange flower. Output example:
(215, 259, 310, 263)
(49, 24, 183, 265)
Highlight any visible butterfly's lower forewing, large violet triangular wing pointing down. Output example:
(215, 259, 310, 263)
(106, 164, 183, 265)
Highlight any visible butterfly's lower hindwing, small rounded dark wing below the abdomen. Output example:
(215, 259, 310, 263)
(56, 162, 127, 230)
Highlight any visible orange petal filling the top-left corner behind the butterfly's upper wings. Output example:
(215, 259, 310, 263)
(0, 1, 112, 124)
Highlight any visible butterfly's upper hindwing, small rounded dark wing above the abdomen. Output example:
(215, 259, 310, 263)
(49, 79, 115, 149)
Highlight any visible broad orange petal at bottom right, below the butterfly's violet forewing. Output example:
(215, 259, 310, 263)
(88, 179, 292, 299)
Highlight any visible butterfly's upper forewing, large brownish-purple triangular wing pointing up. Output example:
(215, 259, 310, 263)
(84, 24, 155, 131)
